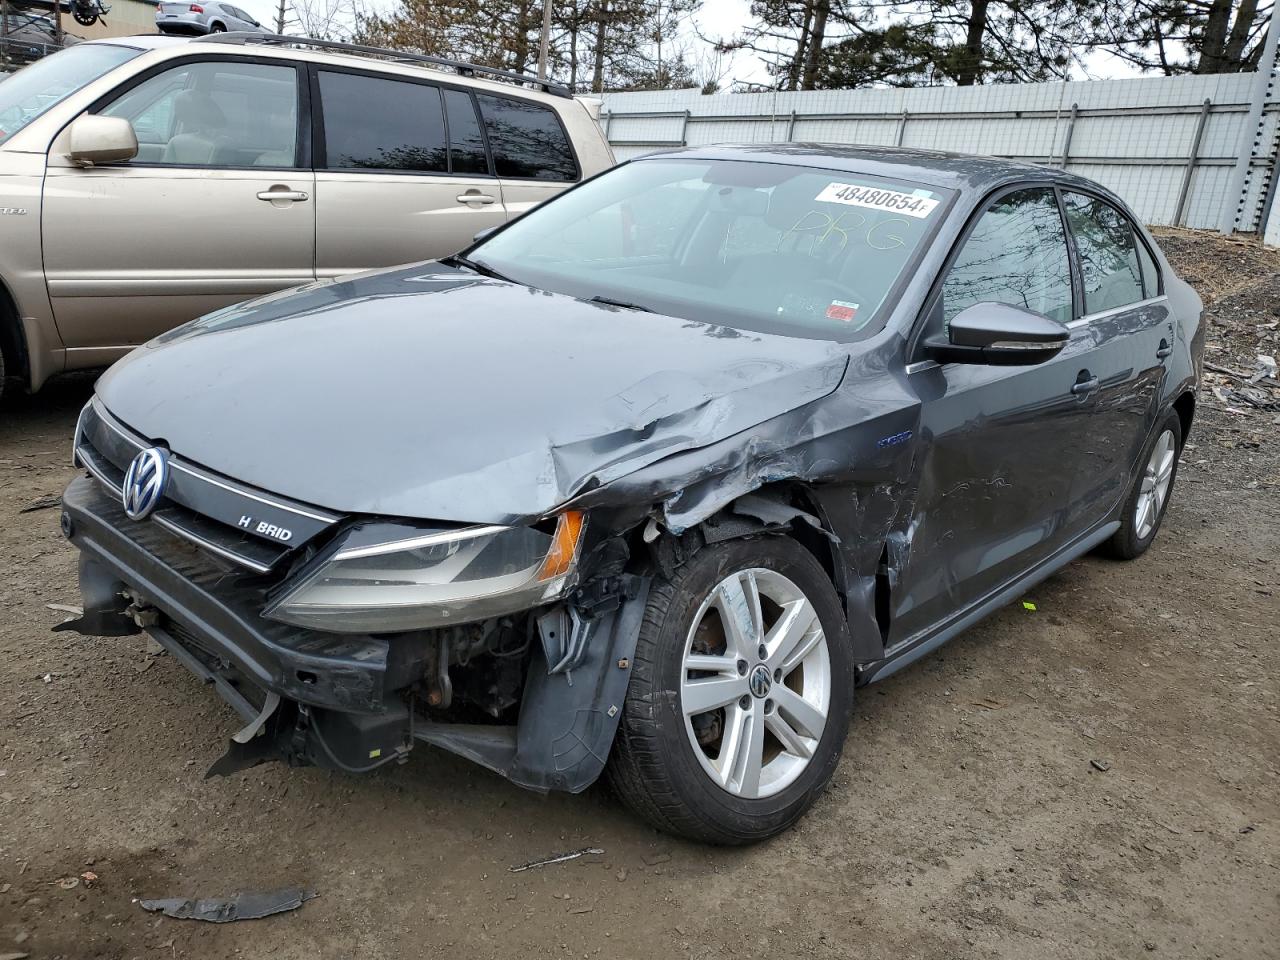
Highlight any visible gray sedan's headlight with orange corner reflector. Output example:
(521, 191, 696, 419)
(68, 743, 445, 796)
(265, 511, 584, 634)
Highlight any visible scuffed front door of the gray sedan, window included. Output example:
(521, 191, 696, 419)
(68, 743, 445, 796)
(890, 186, 1096, 645)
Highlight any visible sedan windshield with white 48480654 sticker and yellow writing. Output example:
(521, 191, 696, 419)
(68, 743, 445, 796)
(467, 159, 950, 340)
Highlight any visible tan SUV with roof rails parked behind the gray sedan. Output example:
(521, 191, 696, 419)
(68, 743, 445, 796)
(0, 33, 613, 389)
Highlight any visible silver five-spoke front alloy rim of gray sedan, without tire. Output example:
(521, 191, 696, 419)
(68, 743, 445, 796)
(680, 567, 832, 799)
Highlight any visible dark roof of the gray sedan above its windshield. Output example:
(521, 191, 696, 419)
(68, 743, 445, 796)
(637, 143, 1100, 192)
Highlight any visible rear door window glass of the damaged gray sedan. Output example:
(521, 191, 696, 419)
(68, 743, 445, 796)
(1062, 193, 1143, 314)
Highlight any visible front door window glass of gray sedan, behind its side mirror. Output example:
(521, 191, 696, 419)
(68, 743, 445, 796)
(941, 187, 1071, 335)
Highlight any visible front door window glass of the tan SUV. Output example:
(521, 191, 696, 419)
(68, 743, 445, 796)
(101, 60, 298, 168)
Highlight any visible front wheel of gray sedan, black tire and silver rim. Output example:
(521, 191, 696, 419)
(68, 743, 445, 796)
(608, 536, 854, 844)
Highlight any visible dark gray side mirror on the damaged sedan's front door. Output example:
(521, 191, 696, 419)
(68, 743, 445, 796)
(924, 302, 1071, 366)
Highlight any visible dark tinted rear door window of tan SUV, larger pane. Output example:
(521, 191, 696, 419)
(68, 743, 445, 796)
(320, 70, 449, 173)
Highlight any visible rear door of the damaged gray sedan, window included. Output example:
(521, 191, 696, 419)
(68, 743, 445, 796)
(1062, 191, 1174, 516)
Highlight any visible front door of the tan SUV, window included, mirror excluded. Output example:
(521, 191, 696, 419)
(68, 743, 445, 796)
(42, 58, 315, 349)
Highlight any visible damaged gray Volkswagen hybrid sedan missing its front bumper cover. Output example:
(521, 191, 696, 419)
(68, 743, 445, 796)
(61, 145, 1203, 844)
